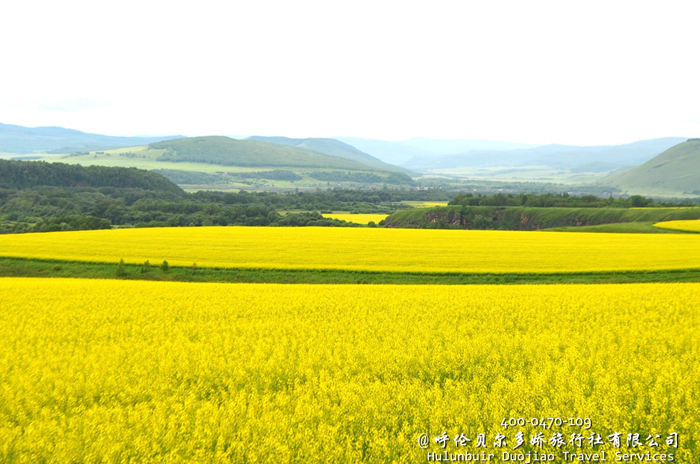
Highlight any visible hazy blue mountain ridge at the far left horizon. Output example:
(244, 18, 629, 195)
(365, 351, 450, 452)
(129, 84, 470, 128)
(0, 124, 180, 154)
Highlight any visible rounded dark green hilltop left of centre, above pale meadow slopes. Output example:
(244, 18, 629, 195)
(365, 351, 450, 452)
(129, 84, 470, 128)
(149, 136, 378, 171)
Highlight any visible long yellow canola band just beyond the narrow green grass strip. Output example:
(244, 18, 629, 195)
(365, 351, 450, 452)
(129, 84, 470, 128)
(0, 227, 700, 272)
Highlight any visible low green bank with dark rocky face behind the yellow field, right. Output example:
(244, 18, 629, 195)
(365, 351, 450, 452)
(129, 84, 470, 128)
(383, 206, 700, 230)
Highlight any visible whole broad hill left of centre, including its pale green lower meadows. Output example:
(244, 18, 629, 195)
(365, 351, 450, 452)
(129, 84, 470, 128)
(43, 137, 413, 190)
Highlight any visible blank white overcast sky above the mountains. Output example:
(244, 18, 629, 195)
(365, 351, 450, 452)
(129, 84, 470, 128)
(0, 0, 700, 144)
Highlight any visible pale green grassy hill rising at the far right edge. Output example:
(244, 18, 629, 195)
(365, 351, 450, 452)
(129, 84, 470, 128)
(602, 139, 700, 195)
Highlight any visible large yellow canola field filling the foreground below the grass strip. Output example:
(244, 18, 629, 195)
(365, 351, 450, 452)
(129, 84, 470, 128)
(0, 278, 700, 463)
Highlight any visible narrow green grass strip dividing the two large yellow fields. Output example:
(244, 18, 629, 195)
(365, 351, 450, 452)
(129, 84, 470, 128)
(0, 258, 700, 285)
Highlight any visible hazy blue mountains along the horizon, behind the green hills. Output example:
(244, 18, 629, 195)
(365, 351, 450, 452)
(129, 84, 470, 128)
(0, 124, 686, 173)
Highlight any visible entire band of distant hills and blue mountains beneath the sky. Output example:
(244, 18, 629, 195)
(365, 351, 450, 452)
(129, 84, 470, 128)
(0, 124, 700, 194)
